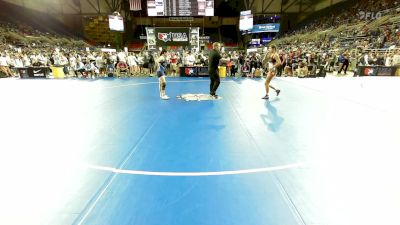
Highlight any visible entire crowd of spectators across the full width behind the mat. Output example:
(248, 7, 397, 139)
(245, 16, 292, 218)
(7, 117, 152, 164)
(0, 0, 400, 78)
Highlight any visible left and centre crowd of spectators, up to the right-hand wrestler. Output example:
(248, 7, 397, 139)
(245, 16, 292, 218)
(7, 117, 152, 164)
(0, 19, 262, 78)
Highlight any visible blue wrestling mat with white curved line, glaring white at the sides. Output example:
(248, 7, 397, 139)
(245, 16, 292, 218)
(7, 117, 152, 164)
(0, 78, 400, 225)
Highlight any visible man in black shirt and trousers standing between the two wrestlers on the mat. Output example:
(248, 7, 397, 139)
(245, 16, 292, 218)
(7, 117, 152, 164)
(208, 42, 221, 98)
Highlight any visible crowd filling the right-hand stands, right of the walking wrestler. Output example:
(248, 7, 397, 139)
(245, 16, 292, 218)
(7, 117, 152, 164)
(268, 0, 400, 76)
